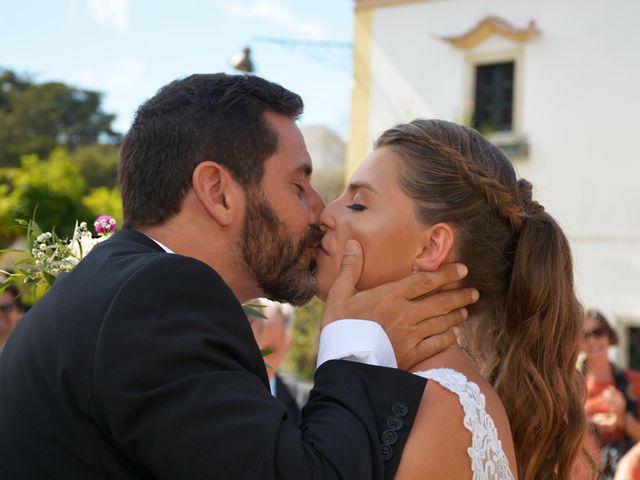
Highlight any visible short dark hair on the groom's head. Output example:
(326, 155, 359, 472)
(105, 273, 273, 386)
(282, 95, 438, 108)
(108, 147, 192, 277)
(119, 73, 303, 228)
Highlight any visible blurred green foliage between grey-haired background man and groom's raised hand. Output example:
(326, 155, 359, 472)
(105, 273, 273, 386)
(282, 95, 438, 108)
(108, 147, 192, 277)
(280, 297, 324, 381)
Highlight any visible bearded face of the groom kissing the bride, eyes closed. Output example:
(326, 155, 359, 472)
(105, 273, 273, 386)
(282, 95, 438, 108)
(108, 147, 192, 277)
(238, 113, 324, 305)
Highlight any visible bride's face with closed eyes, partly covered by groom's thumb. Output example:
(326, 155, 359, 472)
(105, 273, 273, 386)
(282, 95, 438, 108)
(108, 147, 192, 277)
(317, 147, 425, 300)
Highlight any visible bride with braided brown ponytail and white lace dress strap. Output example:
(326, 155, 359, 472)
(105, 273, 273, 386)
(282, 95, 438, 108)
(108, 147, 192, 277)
(318, 120, 586, 479)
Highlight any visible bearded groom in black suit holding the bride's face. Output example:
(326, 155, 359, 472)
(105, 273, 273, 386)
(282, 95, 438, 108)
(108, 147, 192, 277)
(0, 74, 472, 480)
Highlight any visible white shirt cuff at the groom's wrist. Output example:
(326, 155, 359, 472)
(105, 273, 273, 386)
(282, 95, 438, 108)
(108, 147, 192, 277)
(317, 319, 398, 368)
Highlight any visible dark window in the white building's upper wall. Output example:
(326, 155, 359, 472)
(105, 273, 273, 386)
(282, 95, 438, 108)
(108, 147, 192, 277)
(473, 62, 514, 133)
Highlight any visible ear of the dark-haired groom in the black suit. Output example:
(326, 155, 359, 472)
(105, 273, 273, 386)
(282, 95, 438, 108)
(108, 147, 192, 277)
(191, 160, 243, 226)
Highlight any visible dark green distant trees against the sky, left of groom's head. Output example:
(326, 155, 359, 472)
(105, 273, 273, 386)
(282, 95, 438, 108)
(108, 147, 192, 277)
(0, 70, 120, 166)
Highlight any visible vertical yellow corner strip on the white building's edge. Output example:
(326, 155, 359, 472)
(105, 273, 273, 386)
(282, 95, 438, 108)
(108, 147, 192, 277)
(345, 8, 374, 180)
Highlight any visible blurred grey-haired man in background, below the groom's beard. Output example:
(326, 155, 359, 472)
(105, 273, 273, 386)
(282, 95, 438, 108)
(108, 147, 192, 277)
(251, 298, 311, 425)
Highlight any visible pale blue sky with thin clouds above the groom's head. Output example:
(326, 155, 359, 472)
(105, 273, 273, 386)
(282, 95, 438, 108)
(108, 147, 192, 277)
(0, 0, 353, 137)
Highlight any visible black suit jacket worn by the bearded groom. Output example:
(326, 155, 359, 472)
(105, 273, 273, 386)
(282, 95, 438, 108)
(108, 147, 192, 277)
(0, 230, 425, 480)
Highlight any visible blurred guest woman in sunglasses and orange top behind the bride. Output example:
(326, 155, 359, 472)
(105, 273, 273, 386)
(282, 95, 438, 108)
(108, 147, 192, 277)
(582, 310, 640, 479)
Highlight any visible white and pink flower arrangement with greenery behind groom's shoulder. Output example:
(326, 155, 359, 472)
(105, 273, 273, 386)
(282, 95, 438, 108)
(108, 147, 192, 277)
(0, 215, 117, 298)
